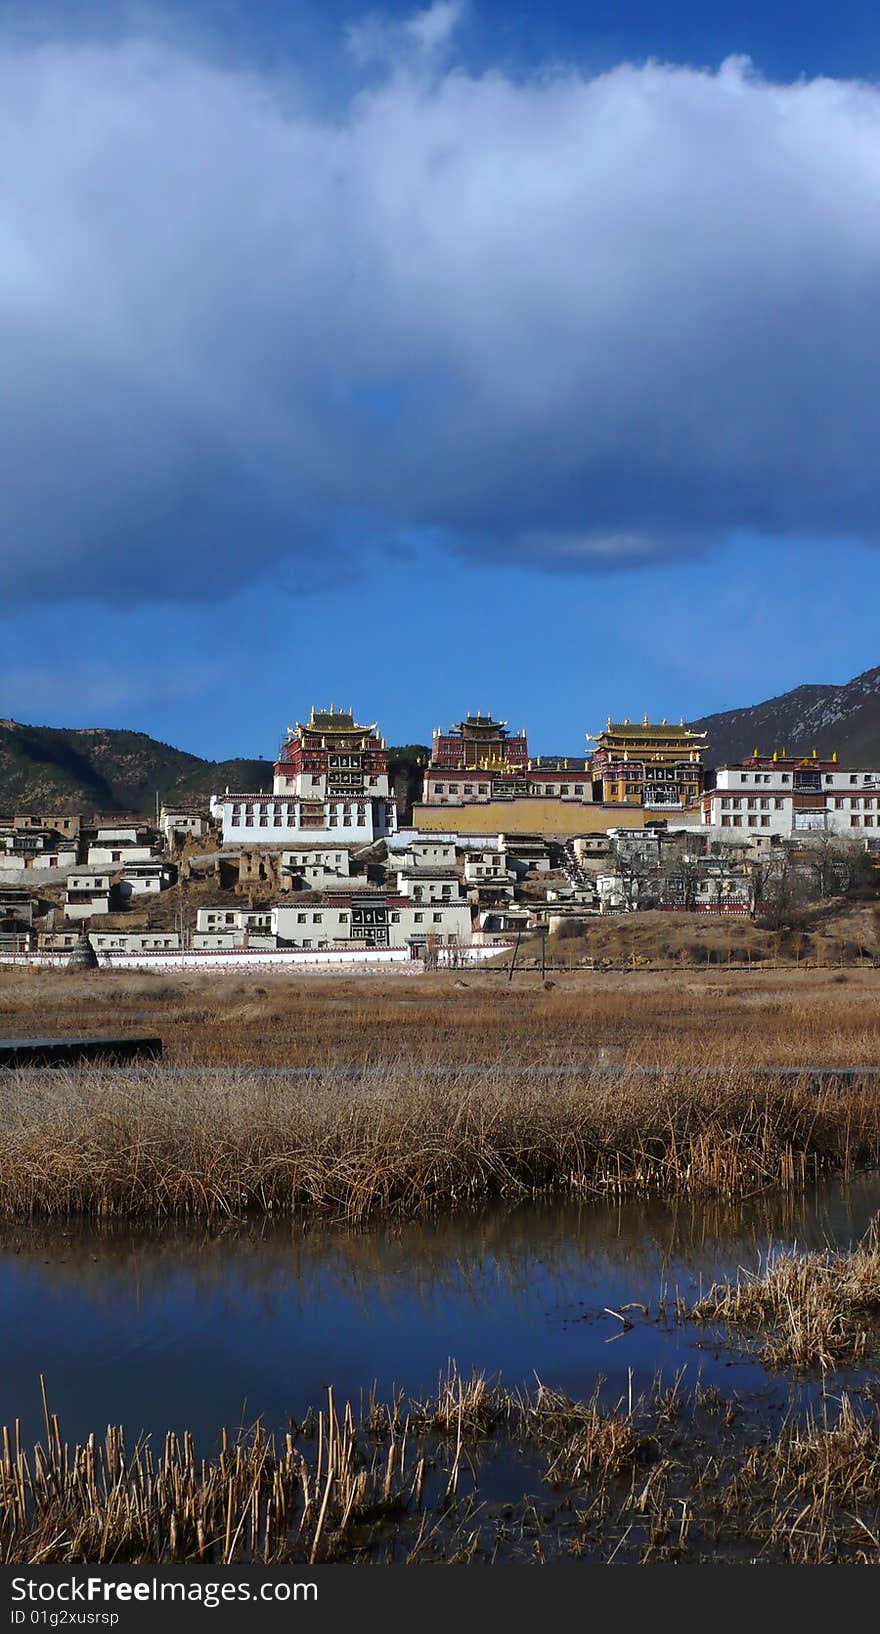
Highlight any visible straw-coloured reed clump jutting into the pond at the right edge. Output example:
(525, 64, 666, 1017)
(687, 1227, 880, 1368)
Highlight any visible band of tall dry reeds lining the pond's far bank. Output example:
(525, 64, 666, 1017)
(0, 1057, 880, 1224)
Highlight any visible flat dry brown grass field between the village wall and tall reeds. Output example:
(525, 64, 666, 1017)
(0, 967, 880, 1067)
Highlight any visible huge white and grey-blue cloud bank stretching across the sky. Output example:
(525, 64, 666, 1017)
(0, 14, 880, 605)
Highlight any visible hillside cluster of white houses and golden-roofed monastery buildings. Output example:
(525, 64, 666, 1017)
(0, 708, 880, 961)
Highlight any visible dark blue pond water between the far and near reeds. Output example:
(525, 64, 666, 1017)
(0, 1175, 880, 1451)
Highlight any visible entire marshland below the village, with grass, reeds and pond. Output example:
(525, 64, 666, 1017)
(0, 967, 880, 1564)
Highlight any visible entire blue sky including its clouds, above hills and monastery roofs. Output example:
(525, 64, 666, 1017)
(0, 0, 880, 758)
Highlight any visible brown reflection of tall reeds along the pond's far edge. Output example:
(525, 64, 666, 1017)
(0, 1175, 880, 1315)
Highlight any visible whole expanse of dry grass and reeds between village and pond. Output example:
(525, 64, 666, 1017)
(0, 971, 880, 1222)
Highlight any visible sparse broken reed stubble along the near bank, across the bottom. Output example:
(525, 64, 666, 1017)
(8, 1369, 880, 1565)
